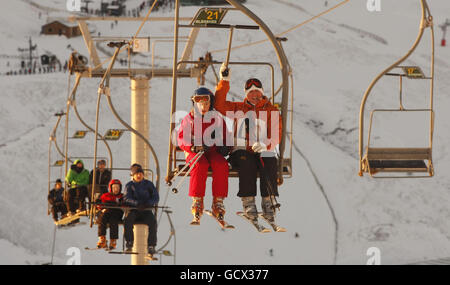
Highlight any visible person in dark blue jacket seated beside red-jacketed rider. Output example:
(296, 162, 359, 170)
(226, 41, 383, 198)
(123, 163, 159, 255)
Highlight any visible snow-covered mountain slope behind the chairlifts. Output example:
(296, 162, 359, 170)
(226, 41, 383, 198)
(0, 0, 450, 264)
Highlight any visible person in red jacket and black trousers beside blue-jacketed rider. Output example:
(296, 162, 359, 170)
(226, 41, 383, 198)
(97, 179, 123, 249)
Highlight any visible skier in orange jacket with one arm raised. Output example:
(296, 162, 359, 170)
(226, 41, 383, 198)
(214, 64, 282, 225)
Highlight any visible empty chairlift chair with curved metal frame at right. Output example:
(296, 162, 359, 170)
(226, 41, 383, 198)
(359, 0, 434, 178)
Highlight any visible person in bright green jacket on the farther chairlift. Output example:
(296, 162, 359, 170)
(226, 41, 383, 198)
(66, 159, 89, 215)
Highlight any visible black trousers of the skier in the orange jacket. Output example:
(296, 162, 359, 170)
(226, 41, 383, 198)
(231, 150, 278, 197)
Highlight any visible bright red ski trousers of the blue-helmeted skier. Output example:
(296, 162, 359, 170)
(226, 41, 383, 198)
(186, 149, 228, 197)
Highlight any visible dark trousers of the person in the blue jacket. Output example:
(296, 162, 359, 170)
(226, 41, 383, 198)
(123, 210, 157, 246)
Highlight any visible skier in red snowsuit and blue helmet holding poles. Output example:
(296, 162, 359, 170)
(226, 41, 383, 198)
(178, 87, 229, 223)
